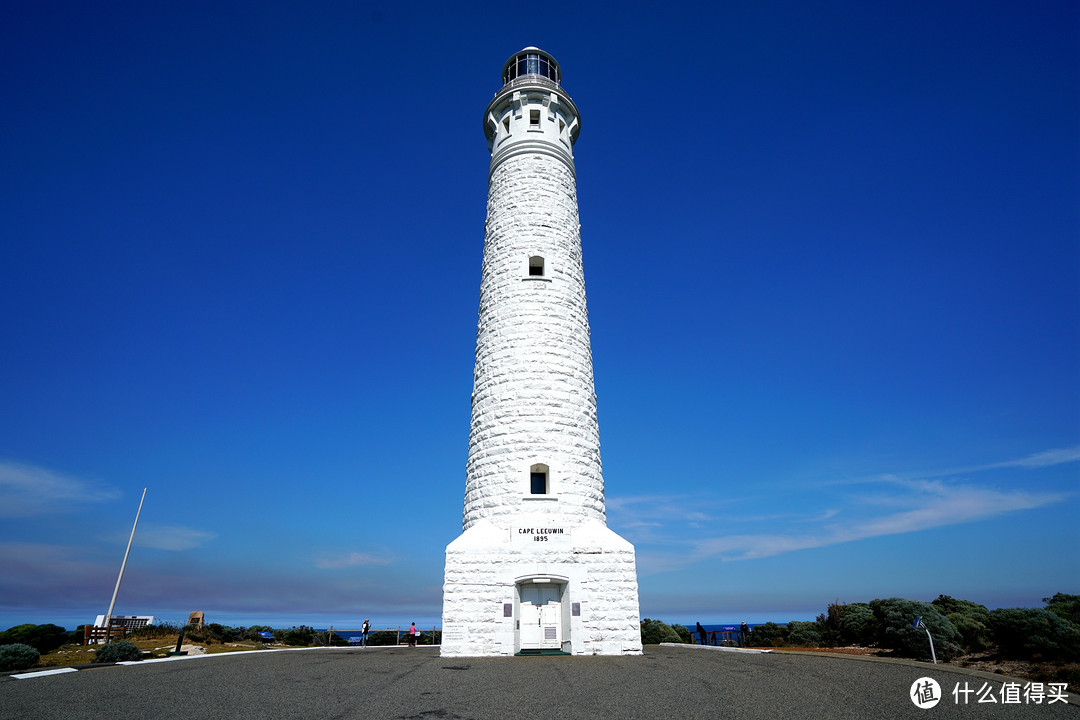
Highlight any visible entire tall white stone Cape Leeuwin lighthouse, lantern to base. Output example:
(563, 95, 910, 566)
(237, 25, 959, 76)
(442, 47, 642, 655)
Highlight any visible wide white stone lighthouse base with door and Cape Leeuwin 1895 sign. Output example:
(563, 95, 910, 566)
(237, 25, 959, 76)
(442, 515, 642, 655)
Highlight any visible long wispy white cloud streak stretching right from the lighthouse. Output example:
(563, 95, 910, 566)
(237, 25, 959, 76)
(608, 447, 1080, 570)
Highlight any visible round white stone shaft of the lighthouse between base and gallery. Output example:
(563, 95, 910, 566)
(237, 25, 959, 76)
(463, 154, 605, 528)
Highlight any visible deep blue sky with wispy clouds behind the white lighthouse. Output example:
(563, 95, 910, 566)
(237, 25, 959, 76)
(0, 0, 1080, 627)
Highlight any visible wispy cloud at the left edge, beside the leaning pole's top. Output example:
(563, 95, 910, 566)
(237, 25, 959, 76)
(0, 460, 120, 517)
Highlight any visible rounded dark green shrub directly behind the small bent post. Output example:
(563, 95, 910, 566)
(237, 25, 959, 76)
(870, 598, 962, 661)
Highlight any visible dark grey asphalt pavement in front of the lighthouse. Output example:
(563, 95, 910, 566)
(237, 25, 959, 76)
(0, 647, 1080, 720)
